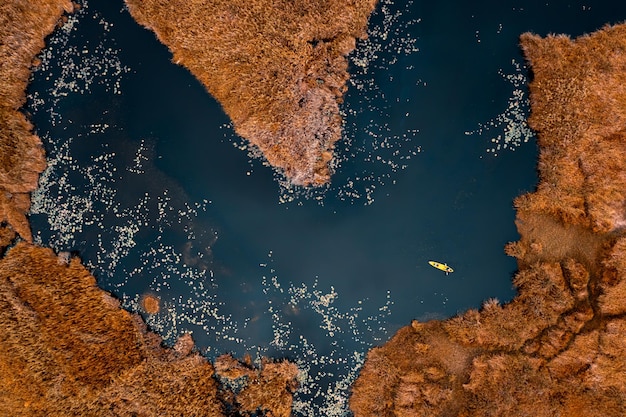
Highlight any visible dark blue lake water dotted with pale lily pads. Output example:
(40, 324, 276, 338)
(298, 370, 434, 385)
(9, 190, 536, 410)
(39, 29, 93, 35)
(26, 0, 626, 416)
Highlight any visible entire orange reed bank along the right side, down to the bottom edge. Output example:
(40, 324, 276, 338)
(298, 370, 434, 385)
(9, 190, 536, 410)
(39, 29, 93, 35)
(350, 25, 626, 417)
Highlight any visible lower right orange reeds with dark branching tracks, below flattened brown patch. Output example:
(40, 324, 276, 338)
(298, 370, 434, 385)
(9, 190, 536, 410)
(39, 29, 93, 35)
(350, 254, 626, 417)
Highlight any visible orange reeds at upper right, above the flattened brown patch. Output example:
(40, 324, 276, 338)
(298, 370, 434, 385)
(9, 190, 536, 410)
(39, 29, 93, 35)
(518, 25, 626, 232)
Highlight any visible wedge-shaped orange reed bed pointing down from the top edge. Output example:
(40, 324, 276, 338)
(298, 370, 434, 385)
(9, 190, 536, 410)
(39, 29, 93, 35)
(126, 0, 376, 185)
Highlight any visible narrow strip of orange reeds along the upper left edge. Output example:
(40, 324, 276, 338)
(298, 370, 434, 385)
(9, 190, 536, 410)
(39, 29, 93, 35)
(0, 0, 73, 242)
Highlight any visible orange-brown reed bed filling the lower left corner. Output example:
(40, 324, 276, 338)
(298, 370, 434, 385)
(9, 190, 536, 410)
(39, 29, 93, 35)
(0, 242, 297, 417)
